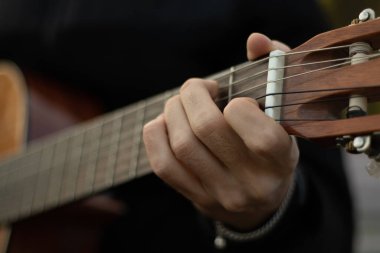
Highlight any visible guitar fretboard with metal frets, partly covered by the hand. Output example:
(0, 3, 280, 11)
(0, 58, 267, 224)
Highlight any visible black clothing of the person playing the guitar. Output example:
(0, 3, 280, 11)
(0, 0, 352, 253)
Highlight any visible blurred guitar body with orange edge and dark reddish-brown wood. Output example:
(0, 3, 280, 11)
(0, 66, 121, 253)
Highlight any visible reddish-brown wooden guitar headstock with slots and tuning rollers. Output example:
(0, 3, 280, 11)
(281, 9, 380, 158)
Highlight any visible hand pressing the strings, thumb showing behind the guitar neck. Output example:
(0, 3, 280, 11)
(143, 34, 298, 231)
